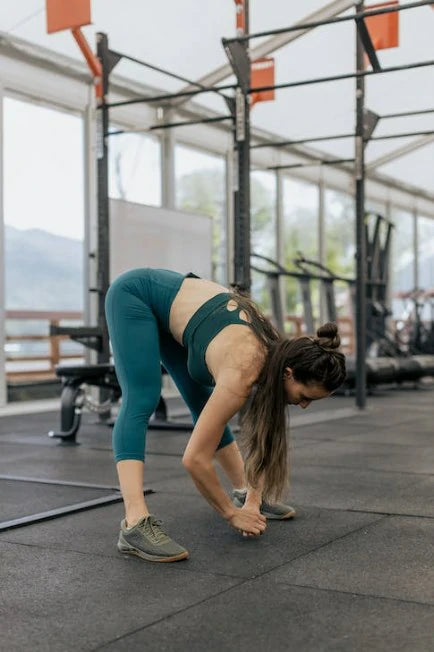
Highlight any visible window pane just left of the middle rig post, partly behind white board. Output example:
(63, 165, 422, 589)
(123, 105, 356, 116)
(175, 145, 227, 285)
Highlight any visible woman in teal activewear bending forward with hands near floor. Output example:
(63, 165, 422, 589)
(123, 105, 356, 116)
(106, 268, 345, 562)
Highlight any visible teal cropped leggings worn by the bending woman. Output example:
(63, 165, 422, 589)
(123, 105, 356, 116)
(106, 269, 234, 462)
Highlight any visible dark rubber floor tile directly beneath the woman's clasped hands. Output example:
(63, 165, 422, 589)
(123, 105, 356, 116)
(139, 494, 382, 577)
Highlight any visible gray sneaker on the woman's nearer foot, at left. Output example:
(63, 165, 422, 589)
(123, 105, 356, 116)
(118, 514, 188, 561)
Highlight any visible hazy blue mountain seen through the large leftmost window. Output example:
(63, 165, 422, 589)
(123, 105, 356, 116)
(5, 226, 84, 310)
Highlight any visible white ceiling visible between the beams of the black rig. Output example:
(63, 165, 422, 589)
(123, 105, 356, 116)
(0, 0, 434, 192)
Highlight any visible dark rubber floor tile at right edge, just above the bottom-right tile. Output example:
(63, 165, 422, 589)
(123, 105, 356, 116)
(270, 516, 434, 605)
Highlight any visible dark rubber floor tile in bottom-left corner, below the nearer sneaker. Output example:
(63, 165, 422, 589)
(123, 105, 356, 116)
(0, 541, 239, 652)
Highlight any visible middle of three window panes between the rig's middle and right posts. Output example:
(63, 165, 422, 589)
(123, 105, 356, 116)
(282, 177, 319, 326)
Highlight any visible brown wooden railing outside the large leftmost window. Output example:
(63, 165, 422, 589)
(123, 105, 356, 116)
(5, 310, 83, 381)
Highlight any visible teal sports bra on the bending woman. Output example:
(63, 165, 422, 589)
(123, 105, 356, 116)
(182, 292, 251, 386)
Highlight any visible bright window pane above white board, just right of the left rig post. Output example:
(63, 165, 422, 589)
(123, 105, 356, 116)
(108, 127, 161, 206)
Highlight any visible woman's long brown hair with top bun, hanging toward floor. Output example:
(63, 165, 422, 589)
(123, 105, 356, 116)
(227, 293, 346, 500)
